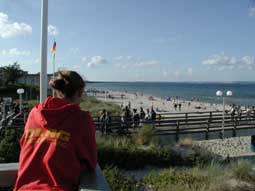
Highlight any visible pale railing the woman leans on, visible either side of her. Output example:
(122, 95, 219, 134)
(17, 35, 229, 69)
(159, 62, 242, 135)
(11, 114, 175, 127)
(0, 163, 111, 191)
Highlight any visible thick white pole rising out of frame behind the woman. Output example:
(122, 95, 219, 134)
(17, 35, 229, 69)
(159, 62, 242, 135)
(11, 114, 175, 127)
(40, 0, 48, 102)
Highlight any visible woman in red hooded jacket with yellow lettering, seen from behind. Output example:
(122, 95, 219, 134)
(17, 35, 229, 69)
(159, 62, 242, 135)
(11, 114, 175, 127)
(14, 71, 97, 191)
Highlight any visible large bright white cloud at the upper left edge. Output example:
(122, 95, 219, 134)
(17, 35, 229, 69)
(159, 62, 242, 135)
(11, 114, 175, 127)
(0, 12, 32, 38)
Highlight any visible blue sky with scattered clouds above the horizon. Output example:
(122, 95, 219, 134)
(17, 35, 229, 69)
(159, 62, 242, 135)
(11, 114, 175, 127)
(0, 0, 255, 81)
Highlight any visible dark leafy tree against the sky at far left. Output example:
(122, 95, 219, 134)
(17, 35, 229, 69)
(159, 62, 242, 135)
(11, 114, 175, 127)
(2, 62, 24, 86)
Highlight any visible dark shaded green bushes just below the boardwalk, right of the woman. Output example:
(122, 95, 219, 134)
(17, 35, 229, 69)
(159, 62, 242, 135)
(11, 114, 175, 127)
(97, 136, 213, 169)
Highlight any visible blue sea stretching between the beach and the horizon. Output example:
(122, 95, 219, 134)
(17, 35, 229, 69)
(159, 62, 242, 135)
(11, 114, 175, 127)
(86, 82, 255, 106)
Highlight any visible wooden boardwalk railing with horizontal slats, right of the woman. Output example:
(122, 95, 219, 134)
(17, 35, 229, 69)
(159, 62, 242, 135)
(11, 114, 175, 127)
(94, 111, 255, 140)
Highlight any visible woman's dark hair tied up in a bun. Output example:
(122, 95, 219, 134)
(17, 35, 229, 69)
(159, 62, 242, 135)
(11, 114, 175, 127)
(49, 71, 85, 97)
